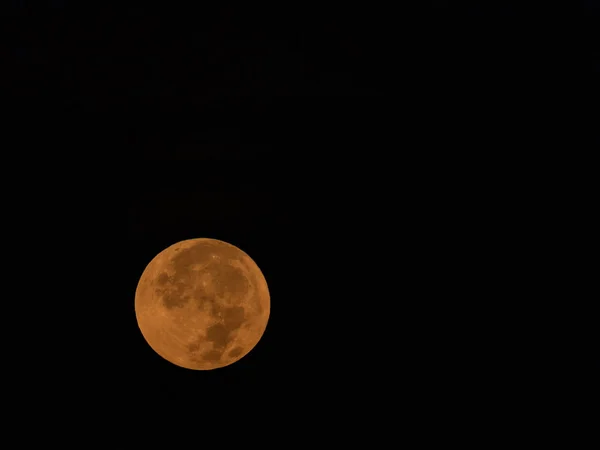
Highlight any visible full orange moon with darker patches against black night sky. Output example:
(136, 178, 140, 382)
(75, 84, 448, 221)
(135, 238, 271, 370)
